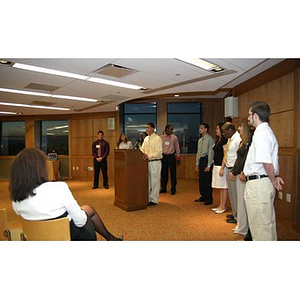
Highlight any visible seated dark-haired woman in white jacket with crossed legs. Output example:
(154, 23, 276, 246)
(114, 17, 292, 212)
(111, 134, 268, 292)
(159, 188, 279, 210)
(9, 149, 123, 241)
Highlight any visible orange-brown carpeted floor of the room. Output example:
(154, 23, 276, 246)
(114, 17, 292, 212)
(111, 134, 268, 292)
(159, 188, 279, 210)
(0, 179, 300, 241)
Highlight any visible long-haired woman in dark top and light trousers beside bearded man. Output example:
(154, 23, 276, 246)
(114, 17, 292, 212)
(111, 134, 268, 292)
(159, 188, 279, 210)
(229, 118, 253, 236)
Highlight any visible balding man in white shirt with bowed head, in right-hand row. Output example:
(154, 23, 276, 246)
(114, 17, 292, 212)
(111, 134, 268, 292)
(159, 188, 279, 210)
(222, 122, 242, 223)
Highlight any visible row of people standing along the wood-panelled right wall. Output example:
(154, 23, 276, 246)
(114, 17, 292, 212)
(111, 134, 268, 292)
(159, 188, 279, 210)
(195, 102, 284, 241)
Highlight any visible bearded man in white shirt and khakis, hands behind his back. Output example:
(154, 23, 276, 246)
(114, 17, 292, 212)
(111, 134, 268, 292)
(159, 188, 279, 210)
(243, 102, 284, 241)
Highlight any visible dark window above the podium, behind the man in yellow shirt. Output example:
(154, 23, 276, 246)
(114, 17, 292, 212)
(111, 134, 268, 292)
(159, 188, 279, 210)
(123, 102, 156, 144)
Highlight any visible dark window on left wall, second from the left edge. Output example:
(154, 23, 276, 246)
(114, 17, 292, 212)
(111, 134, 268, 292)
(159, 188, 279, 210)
(41, 120, 69, 155)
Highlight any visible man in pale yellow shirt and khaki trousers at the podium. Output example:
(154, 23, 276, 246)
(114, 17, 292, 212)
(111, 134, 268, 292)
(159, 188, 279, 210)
(140, 122, 162, 205)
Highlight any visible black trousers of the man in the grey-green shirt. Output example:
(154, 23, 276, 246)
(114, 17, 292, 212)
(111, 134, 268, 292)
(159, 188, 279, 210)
(198, 156, 213, 201)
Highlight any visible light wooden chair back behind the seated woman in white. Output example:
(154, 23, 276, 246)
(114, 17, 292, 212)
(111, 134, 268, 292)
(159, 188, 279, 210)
(21, 217, 71, 241)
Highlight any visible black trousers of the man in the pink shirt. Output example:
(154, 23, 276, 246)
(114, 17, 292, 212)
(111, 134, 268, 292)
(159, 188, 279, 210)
(161, 153, 177, 192)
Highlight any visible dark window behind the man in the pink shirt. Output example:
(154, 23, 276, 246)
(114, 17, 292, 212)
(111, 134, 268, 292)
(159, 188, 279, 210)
(167, 102, 202, 153)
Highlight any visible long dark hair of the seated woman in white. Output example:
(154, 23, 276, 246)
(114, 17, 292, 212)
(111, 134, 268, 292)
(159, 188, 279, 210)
(9, 148, 48, 202)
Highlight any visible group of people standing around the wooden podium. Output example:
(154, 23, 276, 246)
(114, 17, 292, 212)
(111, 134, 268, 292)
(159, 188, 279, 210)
(92, 122, 180, 206)
